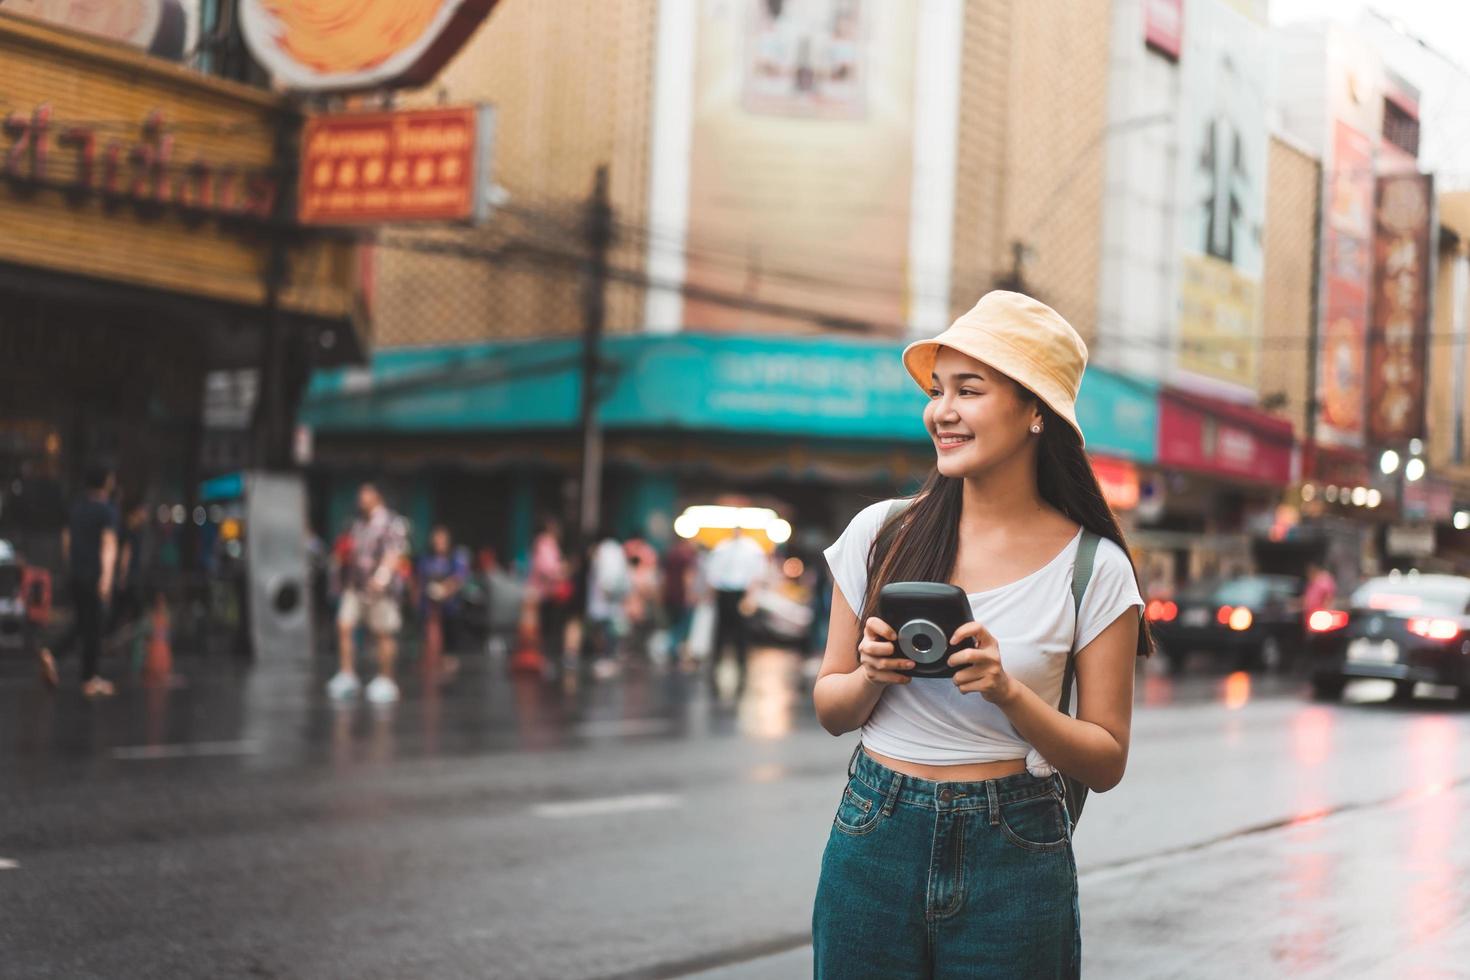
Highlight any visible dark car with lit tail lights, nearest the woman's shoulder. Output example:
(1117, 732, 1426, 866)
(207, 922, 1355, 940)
(1144, 574, 1302, 671)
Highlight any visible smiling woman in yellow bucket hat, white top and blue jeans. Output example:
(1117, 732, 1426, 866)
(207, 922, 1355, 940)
(813, 292, 1150, 980)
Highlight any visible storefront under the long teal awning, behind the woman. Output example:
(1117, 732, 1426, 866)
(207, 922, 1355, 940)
(301, 334, 1157, 567)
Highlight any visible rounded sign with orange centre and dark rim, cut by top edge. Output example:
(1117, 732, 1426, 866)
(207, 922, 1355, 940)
(238, 0, 497, 91)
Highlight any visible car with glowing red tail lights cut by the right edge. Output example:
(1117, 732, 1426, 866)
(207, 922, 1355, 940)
(1307, 573, 1470, 699)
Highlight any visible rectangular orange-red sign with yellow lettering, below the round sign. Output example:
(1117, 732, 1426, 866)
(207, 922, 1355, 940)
(300, 106, 491, 225)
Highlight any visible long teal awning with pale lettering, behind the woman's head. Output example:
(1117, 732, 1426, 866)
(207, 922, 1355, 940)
(301, 334, 1158, 461)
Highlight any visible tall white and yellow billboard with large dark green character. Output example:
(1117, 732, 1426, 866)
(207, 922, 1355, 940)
(1175, 0, 1270, 395)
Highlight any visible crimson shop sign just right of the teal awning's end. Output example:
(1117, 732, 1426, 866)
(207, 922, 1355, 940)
(1158, 391, 1292, 486)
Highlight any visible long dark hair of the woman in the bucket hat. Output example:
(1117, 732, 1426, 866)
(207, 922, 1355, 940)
(858, 405, 1154, 657)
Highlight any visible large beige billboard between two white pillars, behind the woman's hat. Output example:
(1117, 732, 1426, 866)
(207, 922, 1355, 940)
(684, 0, 919, 331)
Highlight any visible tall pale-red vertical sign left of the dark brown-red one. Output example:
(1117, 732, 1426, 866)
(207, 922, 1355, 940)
(1317, 119, 1373, 448)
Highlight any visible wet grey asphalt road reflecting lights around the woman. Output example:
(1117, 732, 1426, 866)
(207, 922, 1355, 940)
(0, 651, 1470, 980)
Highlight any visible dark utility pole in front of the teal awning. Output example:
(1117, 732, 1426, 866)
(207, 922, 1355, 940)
(578, 163, 613, 552)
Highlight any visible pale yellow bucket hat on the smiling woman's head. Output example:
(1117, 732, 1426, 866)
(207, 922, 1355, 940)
(904, 289, 1088, 444)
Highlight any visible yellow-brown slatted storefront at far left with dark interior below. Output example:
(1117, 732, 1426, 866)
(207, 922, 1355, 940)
(0, 12, 362, 564)
